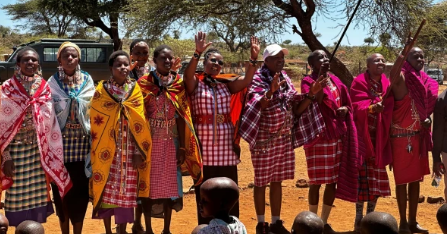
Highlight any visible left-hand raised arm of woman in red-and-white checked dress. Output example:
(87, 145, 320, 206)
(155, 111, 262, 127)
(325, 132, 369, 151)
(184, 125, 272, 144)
(183, 32, 212, 94)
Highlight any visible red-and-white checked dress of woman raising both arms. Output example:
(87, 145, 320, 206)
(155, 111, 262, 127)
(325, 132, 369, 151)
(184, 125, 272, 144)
(191, 81, 240, 166)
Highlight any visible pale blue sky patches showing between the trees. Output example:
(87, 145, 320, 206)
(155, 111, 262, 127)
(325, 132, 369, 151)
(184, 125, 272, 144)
(0, 0, 439, 46)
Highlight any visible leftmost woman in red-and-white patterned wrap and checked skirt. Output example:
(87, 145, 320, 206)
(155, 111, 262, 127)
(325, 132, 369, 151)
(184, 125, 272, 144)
(0, 47, 72, 226)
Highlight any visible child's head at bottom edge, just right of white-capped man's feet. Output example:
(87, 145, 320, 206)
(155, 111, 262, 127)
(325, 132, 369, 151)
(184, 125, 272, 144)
(291, 211, 324, 234)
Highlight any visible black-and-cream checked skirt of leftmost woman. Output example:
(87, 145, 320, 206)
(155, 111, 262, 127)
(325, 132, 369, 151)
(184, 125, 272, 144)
(4, 125, 49, 212)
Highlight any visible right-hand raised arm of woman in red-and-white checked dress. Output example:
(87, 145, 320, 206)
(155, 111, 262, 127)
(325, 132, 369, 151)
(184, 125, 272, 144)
(227, 36, 261, 93)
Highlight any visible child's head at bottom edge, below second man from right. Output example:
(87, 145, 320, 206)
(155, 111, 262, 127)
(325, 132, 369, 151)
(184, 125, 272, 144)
(360, 212, 399, 234)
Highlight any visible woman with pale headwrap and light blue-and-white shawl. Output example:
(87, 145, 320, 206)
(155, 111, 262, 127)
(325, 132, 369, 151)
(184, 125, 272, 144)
(48, 42, 95, 234)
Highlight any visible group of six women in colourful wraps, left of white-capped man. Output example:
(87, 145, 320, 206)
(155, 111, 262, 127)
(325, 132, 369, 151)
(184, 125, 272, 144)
(0, 32, 260, 234)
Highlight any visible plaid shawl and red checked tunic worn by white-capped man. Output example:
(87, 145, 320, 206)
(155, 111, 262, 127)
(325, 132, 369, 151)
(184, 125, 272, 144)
(240, 66, 324, 187)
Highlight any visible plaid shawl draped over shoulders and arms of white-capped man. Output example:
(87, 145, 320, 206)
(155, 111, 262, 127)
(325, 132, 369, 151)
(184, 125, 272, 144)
(239, 66, 324, 148)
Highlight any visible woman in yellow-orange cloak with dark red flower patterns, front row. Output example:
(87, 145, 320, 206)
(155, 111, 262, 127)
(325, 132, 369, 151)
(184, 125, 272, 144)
(90, 50, 152, 234)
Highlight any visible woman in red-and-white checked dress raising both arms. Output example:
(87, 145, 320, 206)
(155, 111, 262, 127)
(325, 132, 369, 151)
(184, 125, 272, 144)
(184, 32, 260, 224)
